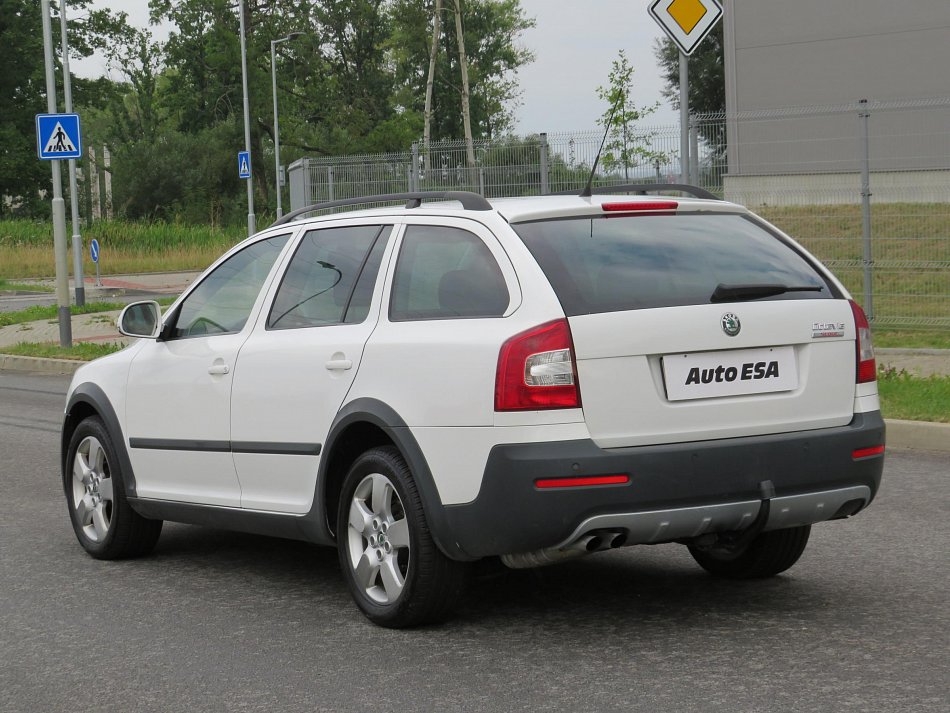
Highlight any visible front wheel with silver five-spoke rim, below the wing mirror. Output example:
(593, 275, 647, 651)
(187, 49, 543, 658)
(64, 416, 162, 560)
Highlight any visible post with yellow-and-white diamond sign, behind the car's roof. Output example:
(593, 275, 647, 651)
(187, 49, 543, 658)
(648, 0, 722, 183)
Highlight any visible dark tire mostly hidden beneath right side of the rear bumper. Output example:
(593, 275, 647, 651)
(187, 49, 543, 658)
(689, 525, 811, 579)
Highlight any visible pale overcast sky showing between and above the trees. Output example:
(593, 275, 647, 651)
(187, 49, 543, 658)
(72, 0, 679, 133)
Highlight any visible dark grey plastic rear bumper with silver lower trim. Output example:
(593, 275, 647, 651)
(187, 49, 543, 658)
(444, 411, 884, 557)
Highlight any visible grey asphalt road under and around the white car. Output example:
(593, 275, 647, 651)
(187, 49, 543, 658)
(0, 372, 950, 713)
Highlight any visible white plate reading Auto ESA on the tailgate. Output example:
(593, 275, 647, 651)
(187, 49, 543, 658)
(662, 347, 798, 401)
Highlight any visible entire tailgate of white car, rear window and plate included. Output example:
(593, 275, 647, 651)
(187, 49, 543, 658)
(513, 203, 856, 448)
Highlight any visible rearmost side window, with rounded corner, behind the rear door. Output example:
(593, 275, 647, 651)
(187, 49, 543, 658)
(389, 225, 510, 322)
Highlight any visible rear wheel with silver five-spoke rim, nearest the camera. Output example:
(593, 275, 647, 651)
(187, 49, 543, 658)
(336, 447, 470, 629)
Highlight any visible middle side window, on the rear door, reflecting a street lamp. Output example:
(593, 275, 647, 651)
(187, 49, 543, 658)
(267, 225, 392, 329)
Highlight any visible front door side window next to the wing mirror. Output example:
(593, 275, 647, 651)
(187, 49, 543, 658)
(173, 234, 290, 337)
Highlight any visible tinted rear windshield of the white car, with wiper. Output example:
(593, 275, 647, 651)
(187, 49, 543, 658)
(512, 213, 834, 316)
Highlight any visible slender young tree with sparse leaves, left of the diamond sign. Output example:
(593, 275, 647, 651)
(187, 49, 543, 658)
(597, 50, 665, 179)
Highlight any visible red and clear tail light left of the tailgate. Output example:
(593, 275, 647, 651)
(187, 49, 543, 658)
(495, 319, 581, 411)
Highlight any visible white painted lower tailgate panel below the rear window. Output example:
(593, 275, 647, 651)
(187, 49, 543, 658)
(569, 299, 855, 448)
